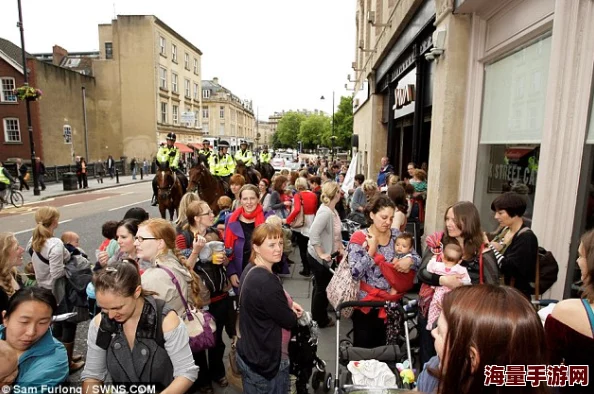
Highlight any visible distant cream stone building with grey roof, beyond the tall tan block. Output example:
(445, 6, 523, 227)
(201, 78, 256, 154)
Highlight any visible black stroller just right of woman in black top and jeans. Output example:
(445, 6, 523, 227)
(289, 312, 332, 394)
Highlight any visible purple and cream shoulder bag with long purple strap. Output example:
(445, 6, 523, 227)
(158, 266, 217, 353)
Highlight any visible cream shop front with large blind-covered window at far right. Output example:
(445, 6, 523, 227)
(454, 0, 594, 299)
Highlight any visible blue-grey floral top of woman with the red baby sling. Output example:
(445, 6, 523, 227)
(347, 228, 421, 299)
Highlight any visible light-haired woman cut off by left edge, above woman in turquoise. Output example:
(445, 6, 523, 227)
(0, 233, 25, 324)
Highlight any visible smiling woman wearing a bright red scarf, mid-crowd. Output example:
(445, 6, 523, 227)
(224, 185, 270, 289)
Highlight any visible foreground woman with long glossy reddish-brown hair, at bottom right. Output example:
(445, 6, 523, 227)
(421, 285, 549, 394)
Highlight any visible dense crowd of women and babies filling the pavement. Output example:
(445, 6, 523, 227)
(0, 152, 594, 394)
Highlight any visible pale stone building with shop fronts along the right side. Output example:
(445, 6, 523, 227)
(352, 0, 594, 298)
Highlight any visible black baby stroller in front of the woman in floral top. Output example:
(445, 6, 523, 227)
(334, 299, 417, 394)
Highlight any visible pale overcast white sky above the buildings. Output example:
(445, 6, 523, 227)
(0, 0, 356, 120)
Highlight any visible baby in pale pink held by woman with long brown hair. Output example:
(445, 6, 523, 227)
(427, 244, 470, 330)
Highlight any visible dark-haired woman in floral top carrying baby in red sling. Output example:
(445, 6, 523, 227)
(348, 194, 421, 348)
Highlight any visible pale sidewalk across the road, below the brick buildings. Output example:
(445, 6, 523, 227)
(21, 174, 154, 204)
